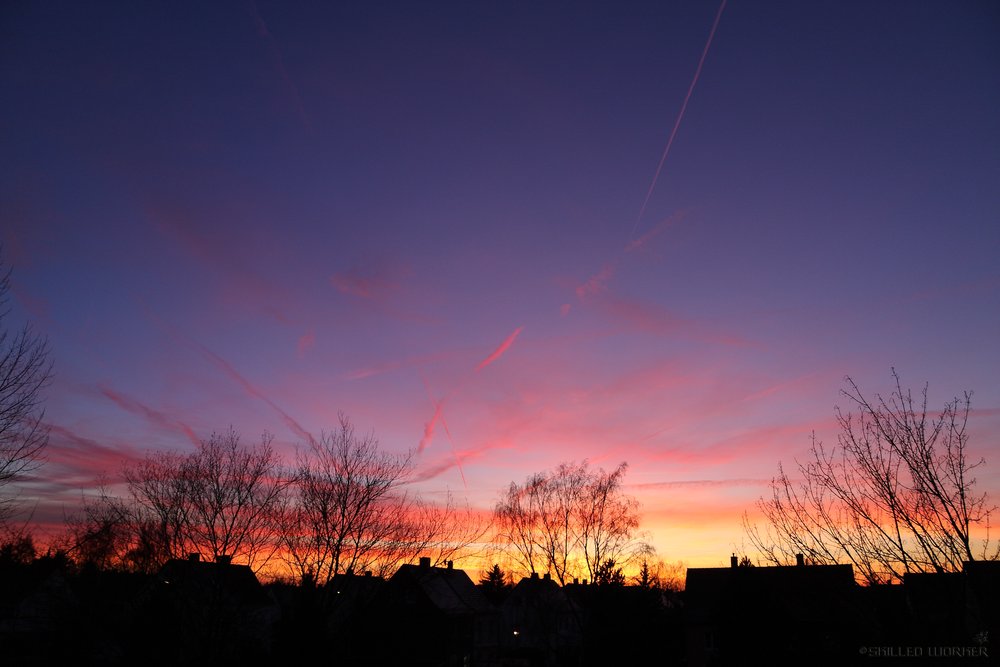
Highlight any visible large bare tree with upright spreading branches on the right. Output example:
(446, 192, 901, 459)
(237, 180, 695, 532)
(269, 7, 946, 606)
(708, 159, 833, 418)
(744, 370, 1000, 583)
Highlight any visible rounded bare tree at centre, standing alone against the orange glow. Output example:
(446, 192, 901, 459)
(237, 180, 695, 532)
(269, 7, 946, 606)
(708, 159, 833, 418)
(494, 461, 652, 584)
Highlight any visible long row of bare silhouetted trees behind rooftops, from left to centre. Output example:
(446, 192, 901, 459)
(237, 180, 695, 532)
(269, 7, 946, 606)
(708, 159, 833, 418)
(3, 415, 653, 584)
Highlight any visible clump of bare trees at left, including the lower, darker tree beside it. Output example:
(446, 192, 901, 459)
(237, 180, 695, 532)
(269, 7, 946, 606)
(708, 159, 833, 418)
(70, 427, 287, 572)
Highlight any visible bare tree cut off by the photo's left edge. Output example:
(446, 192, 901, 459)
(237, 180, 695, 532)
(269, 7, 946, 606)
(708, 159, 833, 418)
(0, 253, 52, 521)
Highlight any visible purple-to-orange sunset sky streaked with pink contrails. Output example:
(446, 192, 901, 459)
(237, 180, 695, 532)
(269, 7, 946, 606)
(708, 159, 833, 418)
(0, 0, 1000, 566)
